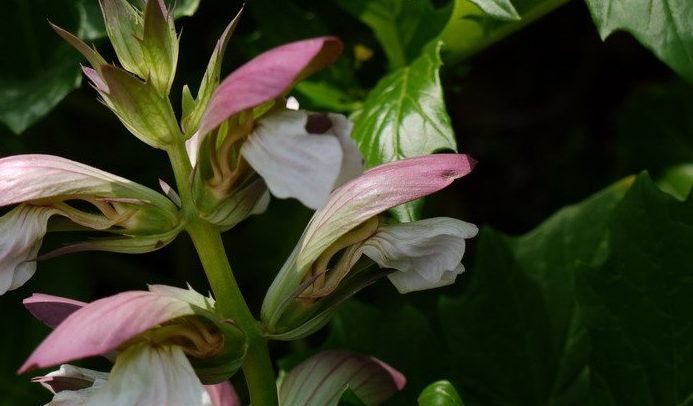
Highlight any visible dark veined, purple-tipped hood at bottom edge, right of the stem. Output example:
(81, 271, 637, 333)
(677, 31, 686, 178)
(279, 350, 404, 406)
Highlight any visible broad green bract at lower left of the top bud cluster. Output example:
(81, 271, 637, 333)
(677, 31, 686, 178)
(101, 65, 180, 149)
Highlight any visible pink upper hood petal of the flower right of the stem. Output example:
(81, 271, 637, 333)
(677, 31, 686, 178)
(297, 154, 476, 269)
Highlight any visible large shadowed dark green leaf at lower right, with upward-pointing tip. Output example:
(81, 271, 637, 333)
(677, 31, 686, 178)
(440, 180, 630, 405)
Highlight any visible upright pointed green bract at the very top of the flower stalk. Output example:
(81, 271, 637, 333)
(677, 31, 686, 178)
(140, 0, 179, 96)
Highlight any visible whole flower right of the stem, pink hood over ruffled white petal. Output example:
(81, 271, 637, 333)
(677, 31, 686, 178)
(261, 154, 477, 339)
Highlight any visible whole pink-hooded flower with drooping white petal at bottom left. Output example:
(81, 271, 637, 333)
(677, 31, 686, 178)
(19, 285, 247, 406)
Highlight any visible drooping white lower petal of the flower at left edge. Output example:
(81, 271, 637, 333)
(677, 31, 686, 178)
(0, 205, 59, 295)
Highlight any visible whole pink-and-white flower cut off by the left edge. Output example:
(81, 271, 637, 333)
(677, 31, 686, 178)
(0, 155, 182, 294)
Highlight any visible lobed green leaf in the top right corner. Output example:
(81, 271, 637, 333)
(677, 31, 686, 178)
(587, 0, 693, 83)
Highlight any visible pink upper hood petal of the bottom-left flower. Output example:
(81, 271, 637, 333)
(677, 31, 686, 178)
(18, 291, 194, 373)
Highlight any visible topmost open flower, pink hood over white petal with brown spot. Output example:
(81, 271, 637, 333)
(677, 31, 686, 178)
(185, 28, 364, 228)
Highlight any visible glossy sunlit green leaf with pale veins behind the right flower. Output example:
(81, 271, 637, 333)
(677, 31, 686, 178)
(352, 41, 457, 221)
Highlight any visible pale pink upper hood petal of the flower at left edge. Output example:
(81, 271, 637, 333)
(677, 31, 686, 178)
(0, 154, 177, 212)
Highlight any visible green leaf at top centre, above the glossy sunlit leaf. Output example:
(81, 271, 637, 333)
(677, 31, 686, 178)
(337, 0, 449, 68)
